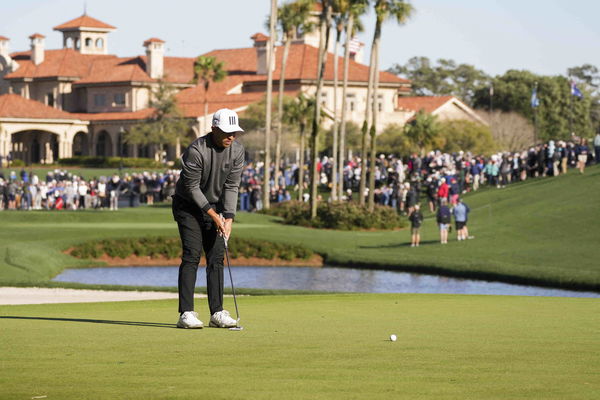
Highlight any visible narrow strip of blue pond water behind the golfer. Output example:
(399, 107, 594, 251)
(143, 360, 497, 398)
(54, 267, 600, 298)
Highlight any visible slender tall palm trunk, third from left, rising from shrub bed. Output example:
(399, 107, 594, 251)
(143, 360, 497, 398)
(310, 0, 331, 219)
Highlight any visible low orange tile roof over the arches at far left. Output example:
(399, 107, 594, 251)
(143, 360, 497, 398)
(0, 94, 79, 119)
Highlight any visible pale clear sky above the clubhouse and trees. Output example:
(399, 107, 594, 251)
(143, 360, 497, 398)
(0, 0, 600, 75)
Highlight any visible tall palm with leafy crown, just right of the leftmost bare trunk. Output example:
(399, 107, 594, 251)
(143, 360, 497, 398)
(275, 0, 314, 191)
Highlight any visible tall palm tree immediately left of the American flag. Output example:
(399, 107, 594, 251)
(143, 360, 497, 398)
(334, 0, 369, 199)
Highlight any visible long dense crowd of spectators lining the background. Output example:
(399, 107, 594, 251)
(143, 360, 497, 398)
(0, 134, 600, 215)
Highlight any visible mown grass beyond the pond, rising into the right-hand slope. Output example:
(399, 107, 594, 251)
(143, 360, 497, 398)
(0, 167, 600, 291)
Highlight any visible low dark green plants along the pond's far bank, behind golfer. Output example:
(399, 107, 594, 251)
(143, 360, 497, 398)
(70, 236, 314, 261)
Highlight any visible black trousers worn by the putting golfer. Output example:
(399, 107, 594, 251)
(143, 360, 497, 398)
(172, 195, 225, 315)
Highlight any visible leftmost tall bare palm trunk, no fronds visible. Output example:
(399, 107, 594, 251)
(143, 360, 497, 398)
(263, 0, 277, 210)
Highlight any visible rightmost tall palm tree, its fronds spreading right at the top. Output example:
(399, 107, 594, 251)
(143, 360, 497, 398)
(366, 0, 414, 211)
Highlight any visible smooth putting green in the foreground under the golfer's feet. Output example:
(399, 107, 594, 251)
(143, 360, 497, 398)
(0, 295, 600, 400)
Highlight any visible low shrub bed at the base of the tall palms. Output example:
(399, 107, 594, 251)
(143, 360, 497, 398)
(264, 201, 406, 230)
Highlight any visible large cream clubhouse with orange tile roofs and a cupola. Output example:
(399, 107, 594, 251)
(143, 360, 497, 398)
(0, 14, 484, 163)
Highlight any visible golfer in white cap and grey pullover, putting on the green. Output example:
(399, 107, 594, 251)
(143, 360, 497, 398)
(173, 108, 244, 328)
